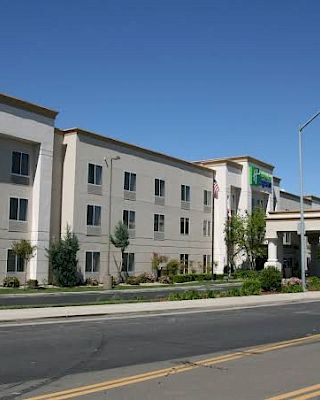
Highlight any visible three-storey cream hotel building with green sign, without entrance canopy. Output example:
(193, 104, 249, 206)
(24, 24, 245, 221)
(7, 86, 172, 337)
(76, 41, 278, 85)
(0, 95, 320, 283)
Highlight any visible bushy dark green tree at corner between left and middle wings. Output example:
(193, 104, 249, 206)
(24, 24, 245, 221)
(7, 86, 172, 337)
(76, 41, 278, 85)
(47, 226, 79, 287)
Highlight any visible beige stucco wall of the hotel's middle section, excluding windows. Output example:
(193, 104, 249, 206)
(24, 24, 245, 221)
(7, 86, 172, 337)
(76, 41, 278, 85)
(62, 134, 212, 278)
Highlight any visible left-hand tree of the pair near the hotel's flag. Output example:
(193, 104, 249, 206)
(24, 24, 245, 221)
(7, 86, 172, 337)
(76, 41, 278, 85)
(224, 214, 245, 274)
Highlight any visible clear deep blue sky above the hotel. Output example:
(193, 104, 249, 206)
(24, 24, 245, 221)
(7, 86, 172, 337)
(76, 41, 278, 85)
(0, 0, 320, 195)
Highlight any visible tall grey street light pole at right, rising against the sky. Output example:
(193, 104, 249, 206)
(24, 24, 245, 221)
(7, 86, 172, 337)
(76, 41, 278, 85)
(299, 111, 320, 291)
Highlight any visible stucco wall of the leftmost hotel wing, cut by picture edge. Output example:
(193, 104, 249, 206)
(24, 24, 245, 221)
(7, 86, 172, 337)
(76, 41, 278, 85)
(0, 104, 54, 283)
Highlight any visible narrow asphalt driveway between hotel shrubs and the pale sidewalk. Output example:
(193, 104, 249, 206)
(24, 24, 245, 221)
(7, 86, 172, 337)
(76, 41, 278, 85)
(0, 283, 241, 306)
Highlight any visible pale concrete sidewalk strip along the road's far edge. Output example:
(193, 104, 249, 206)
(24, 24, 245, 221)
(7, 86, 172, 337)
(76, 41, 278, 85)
(0, 292, 320, 322)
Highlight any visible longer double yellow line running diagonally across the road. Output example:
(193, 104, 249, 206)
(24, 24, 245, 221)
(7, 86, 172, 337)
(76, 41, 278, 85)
(26, 334, 320, 400)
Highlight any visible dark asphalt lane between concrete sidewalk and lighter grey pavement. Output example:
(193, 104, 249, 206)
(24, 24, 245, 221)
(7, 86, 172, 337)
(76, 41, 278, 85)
(0, 302, 320, 399)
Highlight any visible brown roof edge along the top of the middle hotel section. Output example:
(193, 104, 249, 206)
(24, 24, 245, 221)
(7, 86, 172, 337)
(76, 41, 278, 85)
(60, 128, 214, 173)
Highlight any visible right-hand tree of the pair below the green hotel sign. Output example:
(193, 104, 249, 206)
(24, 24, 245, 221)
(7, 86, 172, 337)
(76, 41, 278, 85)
(244, 208, 266, 269)
